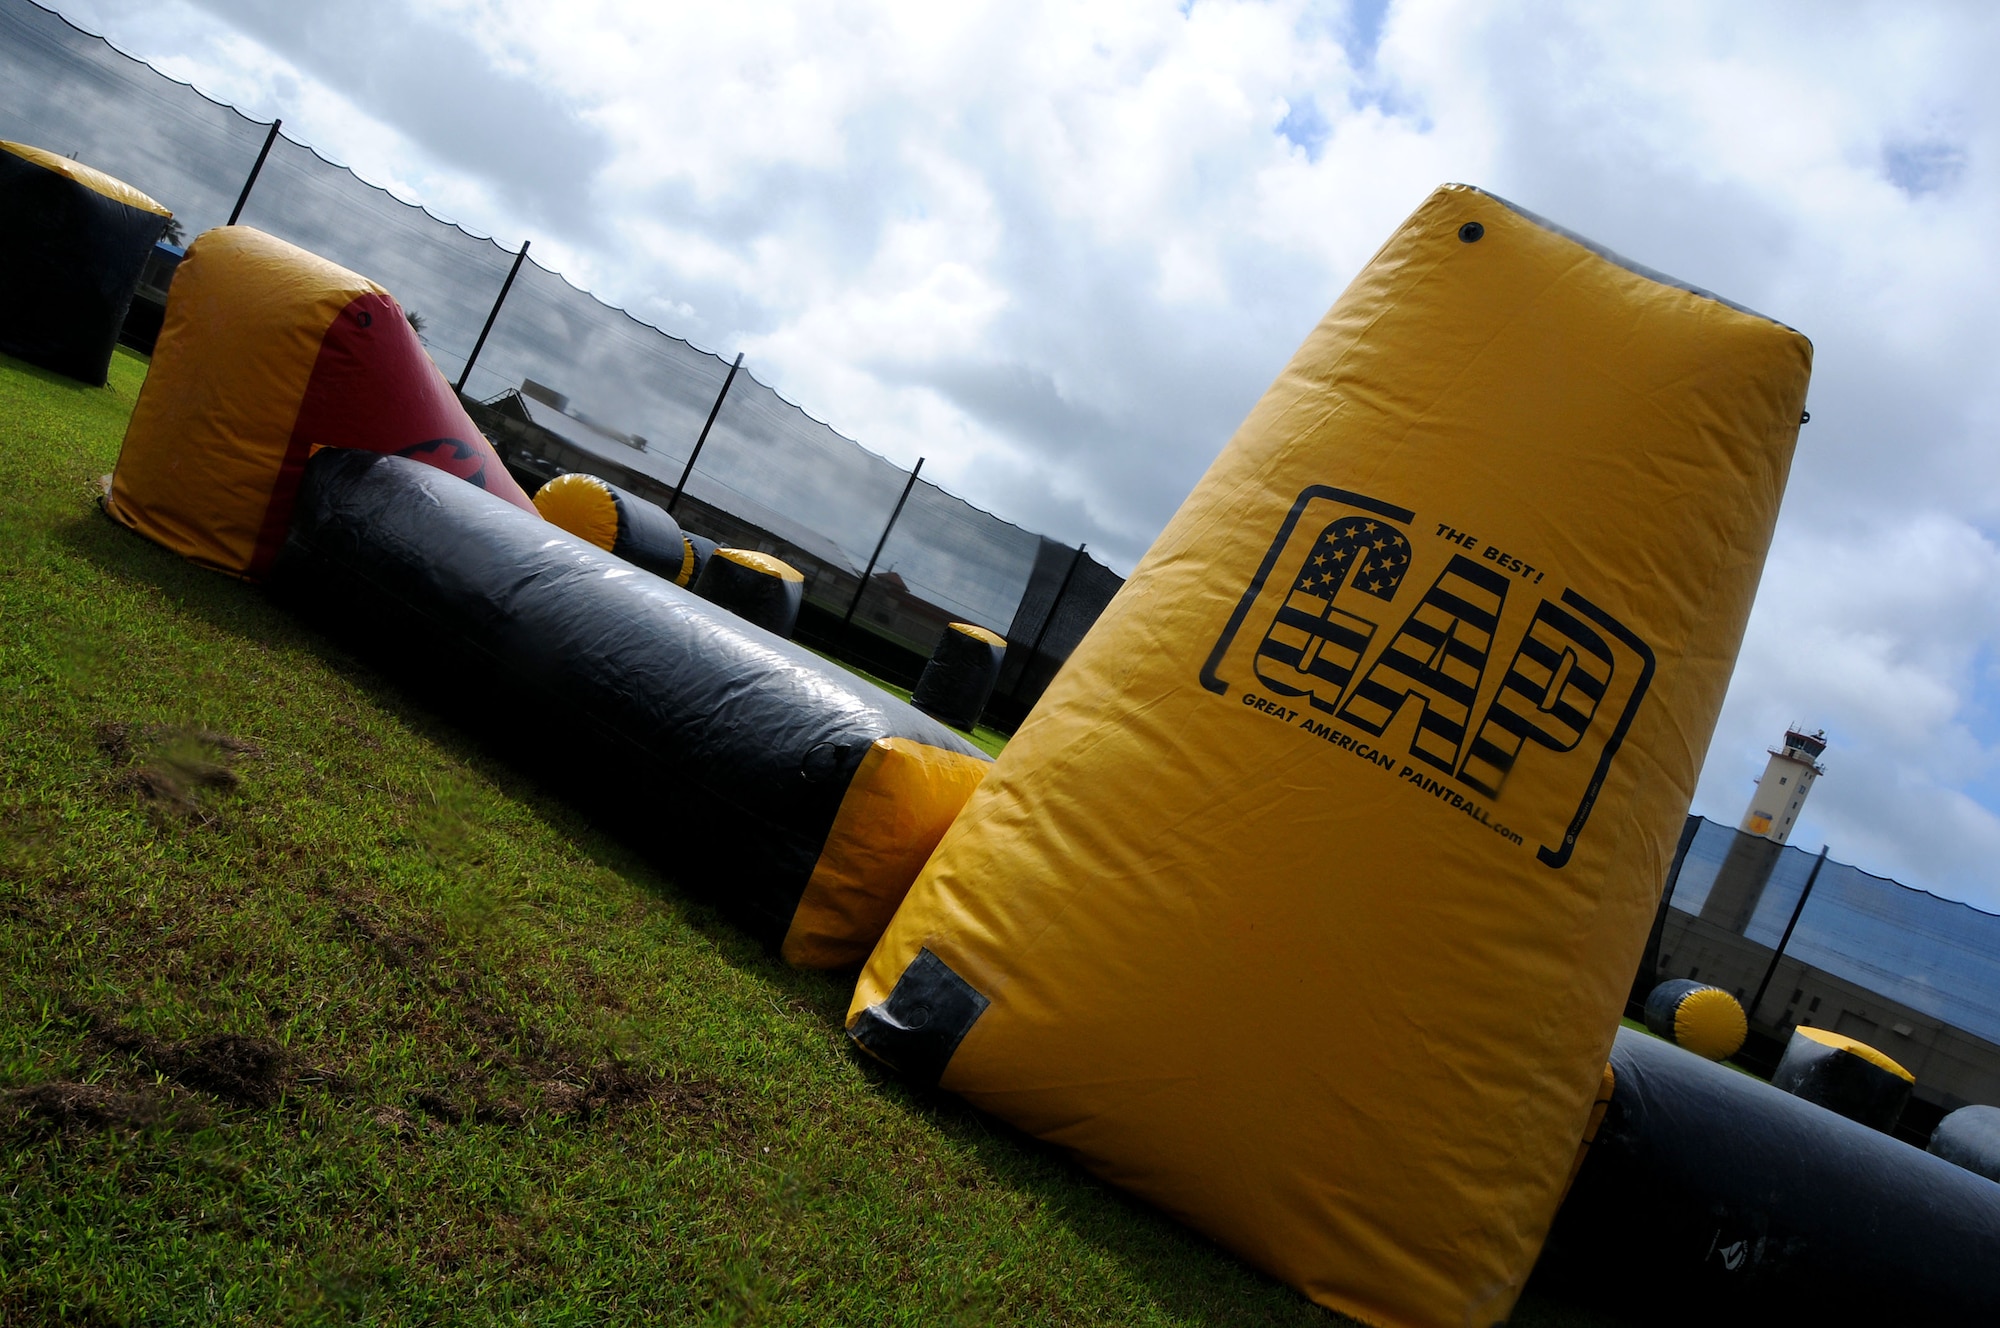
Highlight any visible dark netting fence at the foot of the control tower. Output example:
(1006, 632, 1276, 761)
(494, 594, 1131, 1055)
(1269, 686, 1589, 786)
(1672, 820, 2000, 1042)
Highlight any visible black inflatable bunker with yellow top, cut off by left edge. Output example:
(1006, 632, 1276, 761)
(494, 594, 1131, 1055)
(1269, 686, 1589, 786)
(0, 142, 172, 386)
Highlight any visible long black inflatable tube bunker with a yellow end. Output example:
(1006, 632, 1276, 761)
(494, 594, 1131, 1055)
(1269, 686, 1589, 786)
(270, 448, 988, 968)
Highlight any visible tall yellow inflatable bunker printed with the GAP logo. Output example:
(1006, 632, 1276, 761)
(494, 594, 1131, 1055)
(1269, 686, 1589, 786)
(848, 186, 1812, 1328)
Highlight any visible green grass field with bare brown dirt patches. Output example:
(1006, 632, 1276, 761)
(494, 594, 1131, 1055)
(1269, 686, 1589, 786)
(0, 352, 1624, 1326)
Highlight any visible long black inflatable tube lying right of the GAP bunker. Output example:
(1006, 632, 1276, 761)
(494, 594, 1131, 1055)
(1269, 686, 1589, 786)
(1536, 1028, 2000, 1324)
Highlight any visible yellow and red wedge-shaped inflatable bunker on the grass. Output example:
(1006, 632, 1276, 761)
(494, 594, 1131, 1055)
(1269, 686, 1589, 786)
(104, 226, 534, 580)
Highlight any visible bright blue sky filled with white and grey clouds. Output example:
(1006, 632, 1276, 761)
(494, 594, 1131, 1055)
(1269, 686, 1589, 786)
(39, 0, 2000, 908)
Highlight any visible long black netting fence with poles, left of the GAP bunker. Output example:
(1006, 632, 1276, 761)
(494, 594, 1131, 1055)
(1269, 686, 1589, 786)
(0, 0, 1120, 724)
